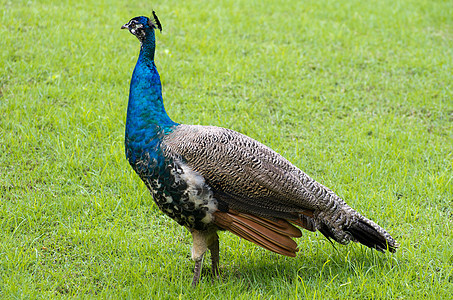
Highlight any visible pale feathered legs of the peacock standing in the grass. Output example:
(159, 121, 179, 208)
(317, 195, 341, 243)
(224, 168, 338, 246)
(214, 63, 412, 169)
(190, 229, 219, 287)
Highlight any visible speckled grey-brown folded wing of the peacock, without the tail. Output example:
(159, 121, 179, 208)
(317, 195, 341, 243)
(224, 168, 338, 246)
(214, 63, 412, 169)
(163, 125, 335, 220)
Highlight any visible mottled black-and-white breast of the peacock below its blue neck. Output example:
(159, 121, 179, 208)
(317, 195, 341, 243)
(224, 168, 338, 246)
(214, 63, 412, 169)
(129, 139, 217, 230)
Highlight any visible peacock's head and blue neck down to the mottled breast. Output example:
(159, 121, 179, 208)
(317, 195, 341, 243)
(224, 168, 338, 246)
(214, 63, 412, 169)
(126, 17, 178, 164)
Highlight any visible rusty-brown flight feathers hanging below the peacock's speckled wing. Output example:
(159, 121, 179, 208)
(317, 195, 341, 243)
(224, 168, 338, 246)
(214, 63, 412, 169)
(214, 211, 302, 257)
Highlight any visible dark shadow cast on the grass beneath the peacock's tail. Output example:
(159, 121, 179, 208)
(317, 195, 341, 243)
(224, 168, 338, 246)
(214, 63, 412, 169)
(207, 247, 404, 290)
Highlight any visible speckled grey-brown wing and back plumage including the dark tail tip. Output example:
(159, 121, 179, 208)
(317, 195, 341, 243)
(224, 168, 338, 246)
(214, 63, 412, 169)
(162, 125, 397, 251)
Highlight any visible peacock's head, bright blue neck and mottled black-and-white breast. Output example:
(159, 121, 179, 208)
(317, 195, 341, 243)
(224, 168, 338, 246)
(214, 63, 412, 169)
(122, 17, 212, 229)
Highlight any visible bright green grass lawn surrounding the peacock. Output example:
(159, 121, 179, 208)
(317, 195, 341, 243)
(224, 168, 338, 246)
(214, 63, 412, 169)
(0, 0, 453, 299)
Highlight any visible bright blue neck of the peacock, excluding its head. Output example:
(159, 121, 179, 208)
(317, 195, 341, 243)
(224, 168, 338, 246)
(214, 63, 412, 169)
(126, 30, 177, 140)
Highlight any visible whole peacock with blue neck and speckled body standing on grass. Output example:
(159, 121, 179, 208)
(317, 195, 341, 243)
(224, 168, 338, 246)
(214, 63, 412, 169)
(121, 11, 398, 286)
